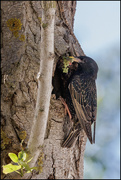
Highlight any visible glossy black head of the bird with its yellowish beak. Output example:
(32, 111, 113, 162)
(71, 56, 98, 79)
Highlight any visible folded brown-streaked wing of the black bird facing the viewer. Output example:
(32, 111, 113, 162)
(68, 75, 97, 143)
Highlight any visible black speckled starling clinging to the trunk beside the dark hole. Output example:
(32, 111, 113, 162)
(53, 56, 98, 148)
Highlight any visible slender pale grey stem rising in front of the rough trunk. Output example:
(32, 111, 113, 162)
(27, 1, 56, 166)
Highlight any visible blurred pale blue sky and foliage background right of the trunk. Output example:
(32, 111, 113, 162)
(74, 1, 120, 179)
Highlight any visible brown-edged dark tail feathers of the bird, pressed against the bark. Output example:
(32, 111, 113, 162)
(61, 124, 80, 148)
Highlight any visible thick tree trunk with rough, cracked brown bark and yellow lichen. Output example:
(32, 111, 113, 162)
(1, 1, 87, 179)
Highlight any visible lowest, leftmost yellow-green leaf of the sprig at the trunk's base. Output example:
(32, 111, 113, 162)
(3, 163, 21, 174)
